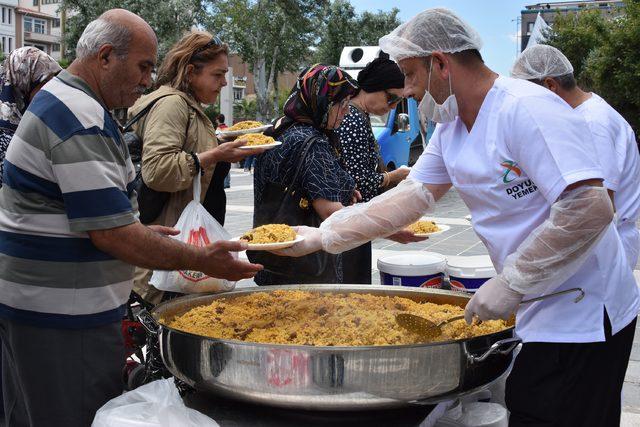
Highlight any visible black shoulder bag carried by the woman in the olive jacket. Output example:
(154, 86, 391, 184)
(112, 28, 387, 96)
(122, 94, 191, 224)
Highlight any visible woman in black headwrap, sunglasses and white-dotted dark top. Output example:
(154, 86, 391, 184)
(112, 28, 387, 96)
(336, 58, 421, 284)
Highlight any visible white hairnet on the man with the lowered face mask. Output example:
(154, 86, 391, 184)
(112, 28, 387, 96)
(380, 8, 482, 61)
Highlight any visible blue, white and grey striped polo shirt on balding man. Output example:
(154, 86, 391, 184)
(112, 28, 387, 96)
(0, 71, 137, 328)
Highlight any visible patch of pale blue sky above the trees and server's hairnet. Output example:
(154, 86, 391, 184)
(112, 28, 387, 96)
(351, 0, 542, 75)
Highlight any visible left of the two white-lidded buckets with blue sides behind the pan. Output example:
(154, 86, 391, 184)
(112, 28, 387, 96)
(378, 252, 446, 288)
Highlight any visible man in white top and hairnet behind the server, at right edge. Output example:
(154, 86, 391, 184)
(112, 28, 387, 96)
(511, 45, 640, 268)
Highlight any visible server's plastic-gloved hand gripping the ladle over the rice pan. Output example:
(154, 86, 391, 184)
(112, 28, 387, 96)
(464, 274, 524, 325)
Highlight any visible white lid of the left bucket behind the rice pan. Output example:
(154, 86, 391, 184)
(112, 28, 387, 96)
(378, 252, 447, 276)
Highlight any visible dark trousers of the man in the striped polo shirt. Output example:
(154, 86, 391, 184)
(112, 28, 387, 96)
(0, 318, 125, 427)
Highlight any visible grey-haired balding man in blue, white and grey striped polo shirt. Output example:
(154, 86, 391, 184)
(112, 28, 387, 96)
(0, 9, 261, 427)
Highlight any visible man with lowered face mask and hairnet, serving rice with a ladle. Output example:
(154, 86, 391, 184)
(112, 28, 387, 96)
(278, 9, 640, 426)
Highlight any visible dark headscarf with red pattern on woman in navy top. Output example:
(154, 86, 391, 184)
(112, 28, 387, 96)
(284, 64, 358, 129)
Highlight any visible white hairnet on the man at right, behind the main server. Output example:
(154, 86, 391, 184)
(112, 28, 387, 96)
(511, 44, 573, 80)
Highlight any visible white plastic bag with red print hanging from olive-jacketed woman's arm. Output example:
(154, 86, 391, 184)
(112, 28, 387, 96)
(149, 179, 238, 294)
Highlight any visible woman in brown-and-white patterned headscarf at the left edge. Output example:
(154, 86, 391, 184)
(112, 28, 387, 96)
(0, 47, 62, 187)
